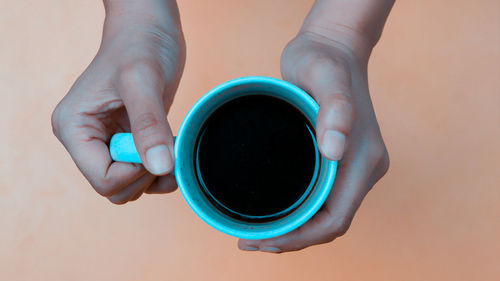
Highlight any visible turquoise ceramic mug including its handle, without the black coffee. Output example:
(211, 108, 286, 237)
(110, 76, 337, 239)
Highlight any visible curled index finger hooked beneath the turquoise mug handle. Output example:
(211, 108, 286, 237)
(60, 118, 146, 197)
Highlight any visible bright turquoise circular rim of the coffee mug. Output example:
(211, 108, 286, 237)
(174, 76, 337, 239)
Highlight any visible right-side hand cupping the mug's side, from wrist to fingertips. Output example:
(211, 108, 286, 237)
(238, 32, 389, 253)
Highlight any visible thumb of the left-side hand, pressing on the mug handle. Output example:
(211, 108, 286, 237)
(119, 60, 174, 175)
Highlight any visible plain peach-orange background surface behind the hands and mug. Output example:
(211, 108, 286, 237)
(0, 0, 500, 280)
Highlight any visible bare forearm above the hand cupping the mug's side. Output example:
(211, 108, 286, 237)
(300, 0, 394, 61)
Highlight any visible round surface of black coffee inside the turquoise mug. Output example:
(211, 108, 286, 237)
(197, 93, 316, 220)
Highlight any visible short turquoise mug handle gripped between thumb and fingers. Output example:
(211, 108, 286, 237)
(109, 133, 142, 163)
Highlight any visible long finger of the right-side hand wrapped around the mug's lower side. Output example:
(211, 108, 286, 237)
(238, 145, 372, 253)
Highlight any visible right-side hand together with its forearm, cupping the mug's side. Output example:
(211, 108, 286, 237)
(238, 0, 393, 253)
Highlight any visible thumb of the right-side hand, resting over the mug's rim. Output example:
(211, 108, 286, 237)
(288, 57, 354, 160)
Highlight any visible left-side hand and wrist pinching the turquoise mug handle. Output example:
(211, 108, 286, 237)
(52, 0, 185, 204)
